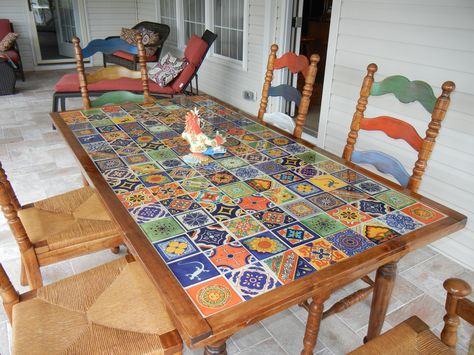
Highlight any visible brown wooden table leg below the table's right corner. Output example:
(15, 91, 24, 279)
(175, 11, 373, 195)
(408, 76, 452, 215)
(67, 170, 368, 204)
(364, 262, 397, 343)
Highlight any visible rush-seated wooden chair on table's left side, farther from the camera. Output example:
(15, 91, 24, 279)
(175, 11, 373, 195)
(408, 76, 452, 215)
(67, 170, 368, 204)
(0, 164, 123, 289)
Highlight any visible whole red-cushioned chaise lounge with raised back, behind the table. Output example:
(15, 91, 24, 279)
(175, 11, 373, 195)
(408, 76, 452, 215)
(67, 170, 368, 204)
(52, 30, 217, 112)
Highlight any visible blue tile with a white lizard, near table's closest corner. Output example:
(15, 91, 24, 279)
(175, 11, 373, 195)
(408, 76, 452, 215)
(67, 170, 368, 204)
(168, 254, 219, 287)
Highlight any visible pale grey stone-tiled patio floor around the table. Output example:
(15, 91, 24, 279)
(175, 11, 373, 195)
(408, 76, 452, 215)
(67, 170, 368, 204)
(0, 71, 474, 355)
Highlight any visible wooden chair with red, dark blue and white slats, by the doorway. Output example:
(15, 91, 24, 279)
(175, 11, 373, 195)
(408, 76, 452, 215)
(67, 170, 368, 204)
(258, 44, 319, 138)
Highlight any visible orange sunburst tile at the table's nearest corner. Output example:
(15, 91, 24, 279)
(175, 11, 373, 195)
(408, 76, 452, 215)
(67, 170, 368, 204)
(186, 276, 242, 317)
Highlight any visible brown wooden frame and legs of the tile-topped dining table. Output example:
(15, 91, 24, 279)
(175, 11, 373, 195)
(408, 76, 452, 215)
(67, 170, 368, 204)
(51, 97, 467, 355)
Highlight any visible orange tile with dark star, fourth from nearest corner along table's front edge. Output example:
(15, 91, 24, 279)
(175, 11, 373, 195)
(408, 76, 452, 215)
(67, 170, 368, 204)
(294, 238, 347, 270)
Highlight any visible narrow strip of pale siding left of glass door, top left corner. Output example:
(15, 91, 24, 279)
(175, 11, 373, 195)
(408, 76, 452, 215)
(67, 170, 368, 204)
(0, 0, 34, 70)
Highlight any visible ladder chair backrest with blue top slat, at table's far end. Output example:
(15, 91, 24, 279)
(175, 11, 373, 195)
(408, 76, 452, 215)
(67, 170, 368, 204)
(72, 34, 153, 109)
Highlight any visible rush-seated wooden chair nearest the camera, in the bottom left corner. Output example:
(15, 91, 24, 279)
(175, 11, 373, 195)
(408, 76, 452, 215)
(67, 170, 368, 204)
(0, 257, 183, 355)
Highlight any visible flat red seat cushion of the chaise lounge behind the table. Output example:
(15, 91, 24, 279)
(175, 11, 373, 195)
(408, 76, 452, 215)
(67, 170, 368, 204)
(54, 73, 176, 94)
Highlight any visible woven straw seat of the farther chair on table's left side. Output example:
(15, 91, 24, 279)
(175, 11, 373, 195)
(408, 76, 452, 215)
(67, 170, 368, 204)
(18, 187, 119, 253)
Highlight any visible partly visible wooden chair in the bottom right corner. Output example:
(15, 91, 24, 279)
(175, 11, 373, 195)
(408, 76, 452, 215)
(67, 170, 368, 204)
(350, 279, 474, 355)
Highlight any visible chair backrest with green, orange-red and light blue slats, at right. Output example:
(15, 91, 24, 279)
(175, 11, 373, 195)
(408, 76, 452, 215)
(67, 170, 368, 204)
(342, 63, 455, 192)
